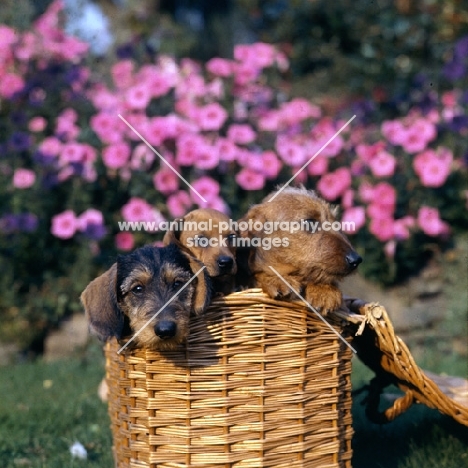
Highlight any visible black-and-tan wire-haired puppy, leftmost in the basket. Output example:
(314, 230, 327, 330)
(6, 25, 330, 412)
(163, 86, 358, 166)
(81, 245, 211, 349)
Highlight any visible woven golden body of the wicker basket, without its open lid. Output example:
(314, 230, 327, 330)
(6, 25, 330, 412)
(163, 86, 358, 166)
(105, 289, 353, 468)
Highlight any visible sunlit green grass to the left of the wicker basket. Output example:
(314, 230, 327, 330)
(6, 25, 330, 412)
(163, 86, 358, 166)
(0, 342, 113, 468)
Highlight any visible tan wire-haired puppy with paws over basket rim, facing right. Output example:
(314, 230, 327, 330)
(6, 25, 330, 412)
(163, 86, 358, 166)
(239, 187, 362, 314)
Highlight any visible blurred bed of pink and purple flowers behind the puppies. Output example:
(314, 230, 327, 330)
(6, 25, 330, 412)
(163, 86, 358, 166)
(0, 2, 468, 350)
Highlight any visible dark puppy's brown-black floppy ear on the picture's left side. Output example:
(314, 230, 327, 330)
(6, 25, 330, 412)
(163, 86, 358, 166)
(80, 263, 124, 341)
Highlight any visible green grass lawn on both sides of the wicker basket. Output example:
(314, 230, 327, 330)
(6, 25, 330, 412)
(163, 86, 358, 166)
(0, 345, 468, 468)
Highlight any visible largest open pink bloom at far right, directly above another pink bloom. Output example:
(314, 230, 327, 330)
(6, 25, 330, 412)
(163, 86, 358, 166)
(413, 148, 453, 187)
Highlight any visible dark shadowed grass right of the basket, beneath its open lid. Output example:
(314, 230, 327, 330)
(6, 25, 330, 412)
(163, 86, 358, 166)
(352, 361, 468, 468)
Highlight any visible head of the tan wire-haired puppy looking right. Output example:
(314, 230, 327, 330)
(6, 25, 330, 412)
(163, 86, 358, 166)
(241, 188, 362, 283)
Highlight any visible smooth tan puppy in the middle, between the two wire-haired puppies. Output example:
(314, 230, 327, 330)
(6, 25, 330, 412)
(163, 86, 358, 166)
(163, 208, 237, 294)
